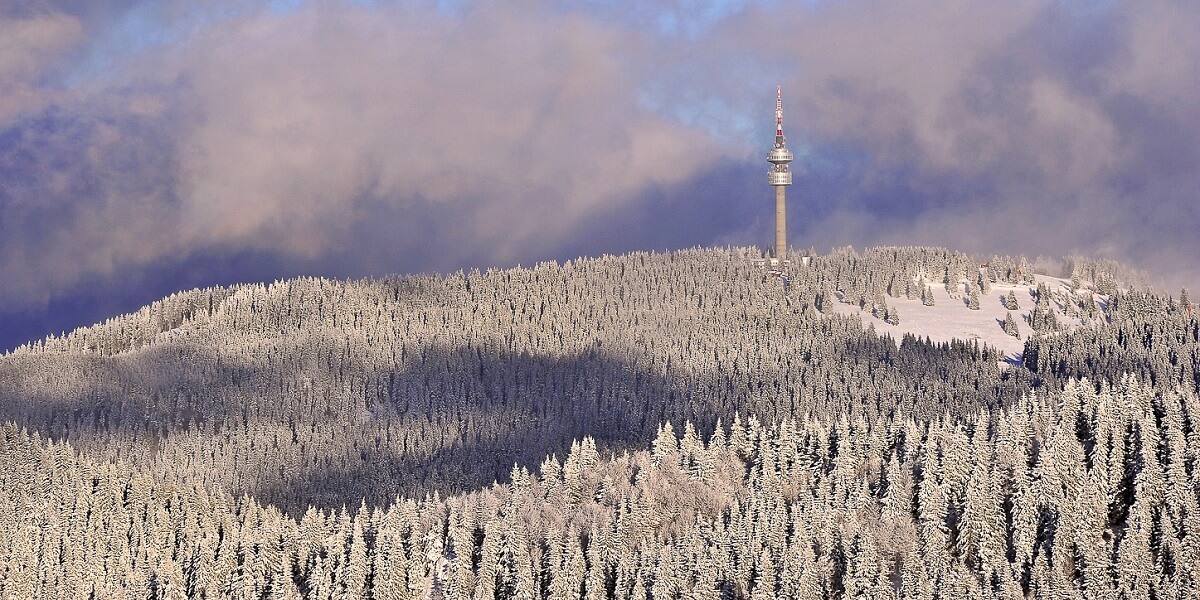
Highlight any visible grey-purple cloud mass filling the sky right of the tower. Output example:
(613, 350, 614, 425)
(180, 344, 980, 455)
(692, 0, 1200, 286)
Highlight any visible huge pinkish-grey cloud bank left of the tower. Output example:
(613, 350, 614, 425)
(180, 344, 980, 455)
(0, 2, 721, 308)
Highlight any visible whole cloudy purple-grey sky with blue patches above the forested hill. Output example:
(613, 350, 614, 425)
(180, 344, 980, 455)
(0, 0, 1200, 349)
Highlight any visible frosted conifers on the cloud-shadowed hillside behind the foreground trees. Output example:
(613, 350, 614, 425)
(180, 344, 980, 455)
(0, 248, 1033, 514)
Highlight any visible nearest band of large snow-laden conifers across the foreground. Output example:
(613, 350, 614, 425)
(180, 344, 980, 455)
(0, 378, 1200, 600)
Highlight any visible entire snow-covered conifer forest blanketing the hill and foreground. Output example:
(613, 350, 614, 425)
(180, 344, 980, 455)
(0, 247, 1200, 600)
